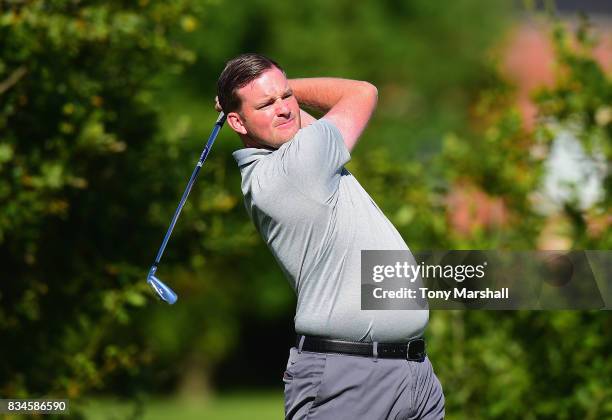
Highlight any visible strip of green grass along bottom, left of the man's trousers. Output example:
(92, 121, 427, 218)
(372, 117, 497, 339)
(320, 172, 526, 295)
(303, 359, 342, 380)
(82, 392, 283, 420)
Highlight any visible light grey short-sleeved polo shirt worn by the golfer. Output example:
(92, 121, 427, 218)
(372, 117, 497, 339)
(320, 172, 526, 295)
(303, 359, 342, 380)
(233, 118, 429, 342)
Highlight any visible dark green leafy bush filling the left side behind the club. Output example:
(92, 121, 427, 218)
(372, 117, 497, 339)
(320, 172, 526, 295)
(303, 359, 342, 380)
(0, 0, 206, 406)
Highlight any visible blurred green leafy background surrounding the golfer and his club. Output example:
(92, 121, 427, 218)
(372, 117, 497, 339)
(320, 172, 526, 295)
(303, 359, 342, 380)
(0, 0, 612, 419)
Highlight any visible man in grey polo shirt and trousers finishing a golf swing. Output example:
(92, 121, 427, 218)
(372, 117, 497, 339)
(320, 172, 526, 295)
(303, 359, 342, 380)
(216, 54, 444, 420)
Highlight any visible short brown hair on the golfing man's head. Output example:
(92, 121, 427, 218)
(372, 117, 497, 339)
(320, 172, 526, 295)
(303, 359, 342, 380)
(217, 53, 285, 114)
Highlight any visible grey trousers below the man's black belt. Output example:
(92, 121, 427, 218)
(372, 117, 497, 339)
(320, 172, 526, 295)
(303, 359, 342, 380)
(283, 347, 444, 420)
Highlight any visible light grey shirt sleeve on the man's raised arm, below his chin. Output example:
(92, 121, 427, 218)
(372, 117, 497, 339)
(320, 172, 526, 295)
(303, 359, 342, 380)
(279, 118, 351, 202)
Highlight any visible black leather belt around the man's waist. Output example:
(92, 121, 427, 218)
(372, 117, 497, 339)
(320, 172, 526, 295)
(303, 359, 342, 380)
(295, 335, 427, 361)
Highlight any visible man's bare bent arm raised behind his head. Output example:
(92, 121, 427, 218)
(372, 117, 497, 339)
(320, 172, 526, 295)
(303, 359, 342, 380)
(289, 77, 378, 151)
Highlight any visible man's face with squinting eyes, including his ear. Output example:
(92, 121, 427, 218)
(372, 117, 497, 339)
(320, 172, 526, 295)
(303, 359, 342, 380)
(228, 67, 300, 149)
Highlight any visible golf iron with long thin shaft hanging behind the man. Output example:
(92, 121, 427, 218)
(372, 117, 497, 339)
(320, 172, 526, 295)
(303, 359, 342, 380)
(147, 112, 225, 305)
